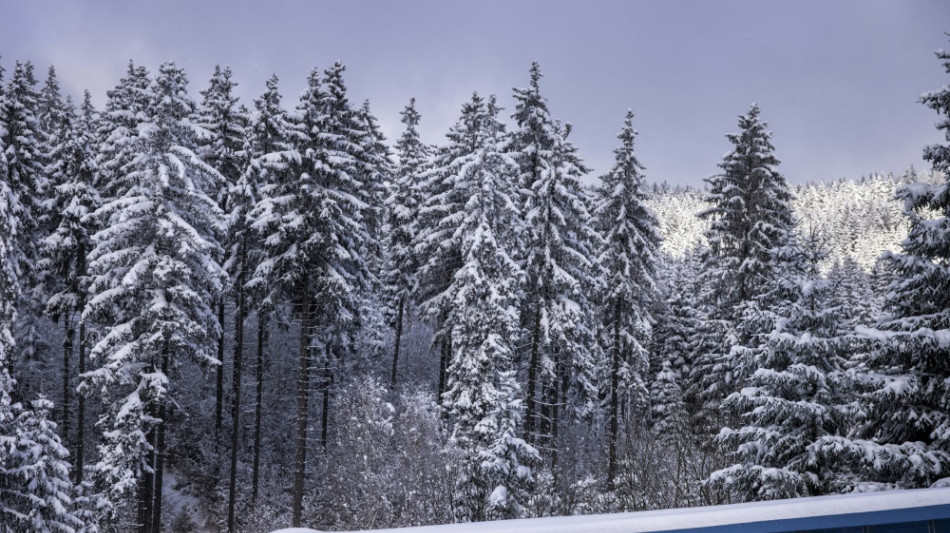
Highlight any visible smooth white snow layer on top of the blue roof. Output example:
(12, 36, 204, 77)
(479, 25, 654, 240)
(274, 488, 950, 533)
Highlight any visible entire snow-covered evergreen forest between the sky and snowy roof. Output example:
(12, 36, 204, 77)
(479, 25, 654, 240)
(0, 42, 950, 533)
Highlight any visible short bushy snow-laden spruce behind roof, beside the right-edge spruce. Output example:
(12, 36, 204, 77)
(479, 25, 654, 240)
(709, 236, 851, 501)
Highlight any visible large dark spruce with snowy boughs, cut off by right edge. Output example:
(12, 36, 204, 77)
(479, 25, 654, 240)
(826, 45, 950, 490)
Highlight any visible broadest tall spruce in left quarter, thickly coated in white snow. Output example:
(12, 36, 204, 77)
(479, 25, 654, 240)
(82, 63, 226, 532)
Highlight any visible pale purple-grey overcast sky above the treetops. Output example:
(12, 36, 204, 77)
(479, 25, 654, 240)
(0, 0, 950, 185)
